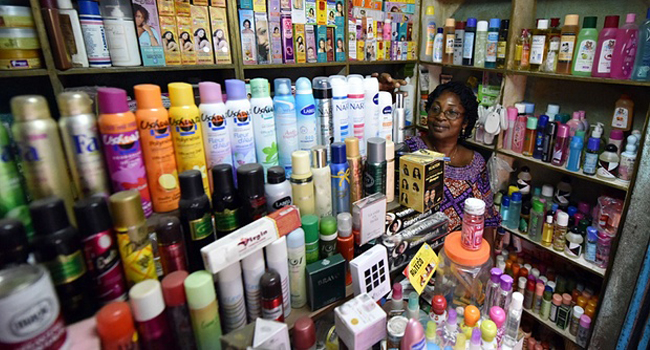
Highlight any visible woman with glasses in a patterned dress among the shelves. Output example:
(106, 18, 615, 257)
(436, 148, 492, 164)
(405, 81, 500, 237)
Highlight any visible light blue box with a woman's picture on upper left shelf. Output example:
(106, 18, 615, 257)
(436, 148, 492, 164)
(131, 0, 165, 67)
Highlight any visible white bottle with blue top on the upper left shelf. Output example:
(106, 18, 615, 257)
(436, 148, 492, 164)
(77, 0, 111, 68)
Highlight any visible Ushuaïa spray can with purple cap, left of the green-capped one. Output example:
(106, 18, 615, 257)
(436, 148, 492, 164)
(225, 79, 256, 169)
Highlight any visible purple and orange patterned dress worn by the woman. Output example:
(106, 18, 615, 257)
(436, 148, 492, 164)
(405, 136, 501, 232)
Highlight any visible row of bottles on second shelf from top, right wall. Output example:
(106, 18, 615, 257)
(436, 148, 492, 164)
(498, 100, 641, 182)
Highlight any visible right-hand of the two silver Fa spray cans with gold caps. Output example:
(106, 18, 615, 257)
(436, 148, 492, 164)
(56, 91, 110, 198)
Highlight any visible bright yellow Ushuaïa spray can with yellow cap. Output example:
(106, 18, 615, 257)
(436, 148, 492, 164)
(167, 83, 210, 195)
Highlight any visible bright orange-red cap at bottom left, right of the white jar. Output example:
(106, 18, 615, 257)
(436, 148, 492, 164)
(95, 301, 135, 341)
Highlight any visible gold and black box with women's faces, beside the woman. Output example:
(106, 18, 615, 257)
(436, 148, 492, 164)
(399, 150, 445, 213)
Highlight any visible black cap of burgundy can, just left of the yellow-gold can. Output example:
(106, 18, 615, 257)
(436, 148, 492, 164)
(74, 196, 113, 237)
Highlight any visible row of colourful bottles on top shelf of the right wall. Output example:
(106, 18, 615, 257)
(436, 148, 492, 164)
(514, 9, 650, 81)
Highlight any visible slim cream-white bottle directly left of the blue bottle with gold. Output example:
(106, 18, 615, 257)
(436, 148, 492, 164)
(311, 146, 332, 218)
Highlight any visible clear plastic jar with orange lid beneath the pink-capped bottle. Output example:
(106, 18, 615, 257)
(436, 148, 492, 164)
(435, 231, 493, 309)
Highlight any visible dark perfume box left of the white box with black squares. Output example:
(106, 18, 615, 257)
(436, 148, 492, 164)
(307, 254, 346, 311)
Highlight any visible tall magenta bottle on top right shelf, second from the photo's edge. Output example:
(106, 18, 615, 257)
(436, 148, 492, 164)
(611, 13, 639, 80)
